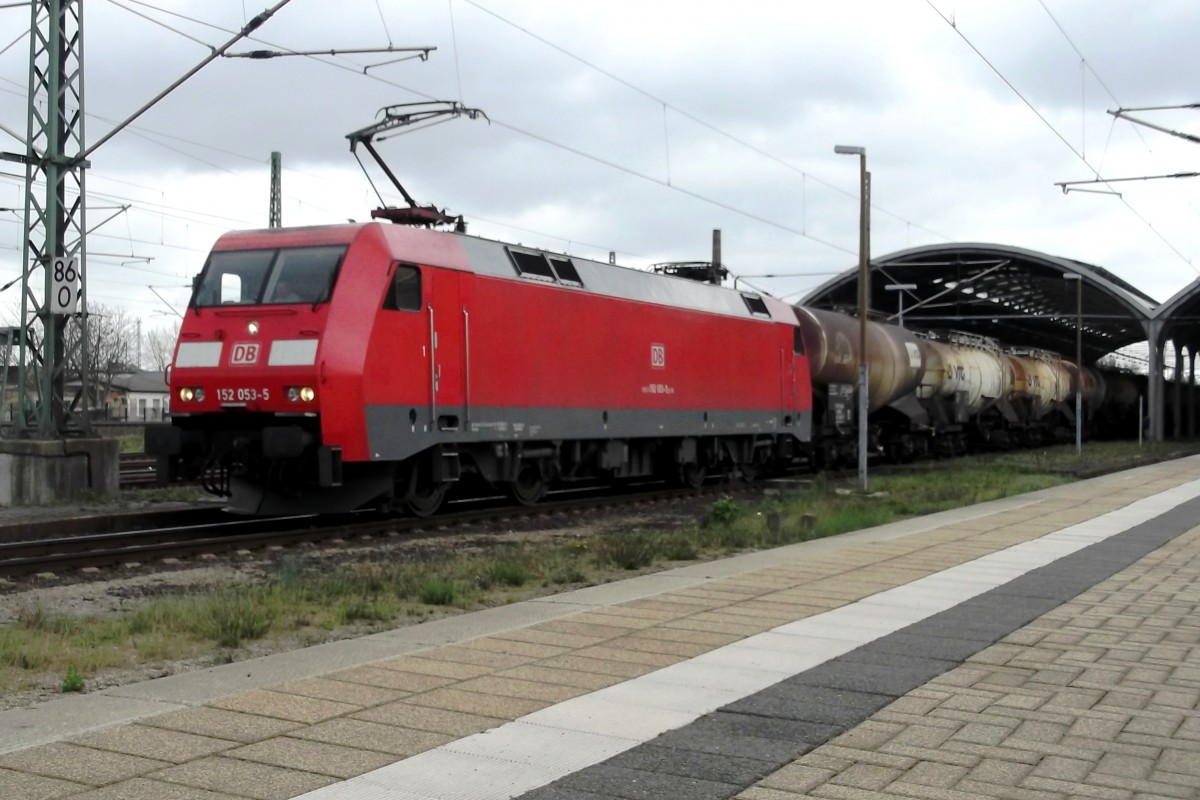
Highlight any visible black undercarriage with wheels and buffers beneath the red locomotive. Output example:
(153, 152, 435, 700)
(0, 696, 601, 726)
(145, 413, 809, 516)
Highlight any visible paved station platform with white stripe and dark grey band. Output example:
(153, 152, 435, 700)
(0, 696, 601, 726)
(0, 458, 1200, 800)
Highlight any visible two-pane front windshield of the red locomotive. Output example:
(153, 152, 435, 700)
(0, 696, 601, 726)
(192, 245, 346, 308)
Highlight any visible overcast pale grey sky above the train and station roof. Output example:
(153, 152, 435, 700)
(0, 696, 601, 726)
(0, 0, 1200, 338)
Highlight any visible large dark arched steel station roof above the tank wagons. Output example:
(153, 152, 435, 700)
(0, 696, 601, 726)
(800, 243, 1156, 362)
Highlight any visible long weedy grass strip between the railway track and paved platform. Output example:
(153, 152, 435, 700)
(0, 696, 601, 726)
(0, 443, 1161, 692)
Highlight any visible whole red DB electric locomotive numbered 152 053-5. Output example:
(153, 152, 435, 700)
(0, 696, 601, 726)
(146, 223, 811, 515)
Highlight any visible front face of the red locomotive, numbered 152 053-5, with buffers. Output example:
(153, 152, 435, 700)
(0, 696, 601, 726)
(146, 237, 348, 515)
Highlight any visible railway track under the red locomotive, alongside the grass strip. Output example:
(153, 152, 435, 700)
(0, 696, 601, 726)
(0, 486, 758, 577)
